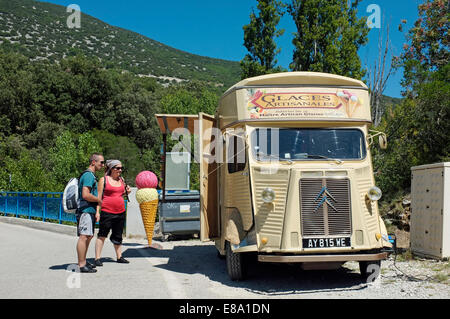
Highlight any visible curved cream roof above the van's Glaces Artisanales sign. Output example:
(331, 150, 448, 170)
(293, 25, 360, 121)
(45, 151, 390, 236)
(224, 71, 367, 95)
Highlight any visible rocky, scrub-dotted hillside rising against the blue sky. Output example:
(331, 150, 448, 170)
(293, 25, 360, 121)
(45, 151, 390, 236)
(0, 0, 240, 89)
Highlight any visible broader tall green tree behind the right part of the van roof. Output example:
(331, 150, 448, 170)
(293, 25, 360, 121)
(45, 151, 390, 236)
(287, 0, 369, 79)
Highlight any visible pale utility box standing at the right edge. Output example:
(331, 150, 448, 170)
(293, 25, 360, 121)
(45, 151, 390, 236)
(410, 162, 450, 259)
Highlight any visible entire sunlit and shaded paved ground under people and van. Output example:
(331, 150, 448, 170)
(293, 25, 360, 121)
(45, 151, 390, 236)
(0, 222, 450, 299)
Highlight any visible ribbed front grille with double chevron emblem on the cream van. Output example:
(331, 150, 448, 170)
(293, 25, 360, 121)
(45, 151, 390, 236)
(299, 178, 352, 237)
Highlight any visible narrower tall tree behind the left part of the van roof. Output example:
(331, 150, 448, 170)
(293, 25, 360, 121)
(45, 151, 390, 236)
(241, 0, 285, 79)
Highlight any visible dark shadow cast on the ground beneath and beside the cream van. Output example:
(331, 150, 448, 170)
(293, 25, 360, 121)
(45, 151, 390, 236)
(123, 243, 367, 296)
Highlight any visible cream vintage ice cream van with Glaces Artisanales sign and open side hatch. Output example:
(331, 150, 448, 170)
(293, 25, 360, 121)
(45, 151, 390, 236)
(156, 72, 392, 280)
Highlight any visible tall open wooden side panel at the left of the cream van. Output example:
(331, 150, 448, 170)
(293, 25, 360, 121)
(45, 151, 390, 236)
(199, 113, 222, 241)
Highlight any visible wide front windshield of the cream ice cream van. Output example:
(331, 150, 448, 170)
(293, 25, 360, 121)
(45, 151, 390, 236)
(251, 128, 366, 161)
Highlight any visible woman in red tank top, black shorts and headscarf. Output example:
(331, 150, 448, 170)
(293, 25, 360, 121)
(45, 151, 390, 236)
(95, 160, 130, 266)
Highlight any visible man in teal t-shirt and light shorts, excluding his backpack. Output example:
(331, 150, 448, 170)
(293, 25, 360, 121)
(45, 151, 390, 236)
(76, 153, 105, 273)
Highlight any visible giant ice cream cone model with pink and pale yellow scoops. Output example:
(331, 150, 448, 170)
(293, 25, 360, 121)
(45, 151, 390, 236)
(136, 171, 158, 246)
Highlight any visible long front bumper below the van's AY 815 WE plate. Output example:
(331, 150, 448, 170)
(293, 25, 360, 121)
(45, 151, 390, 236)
(258, 252, 388, 263)
